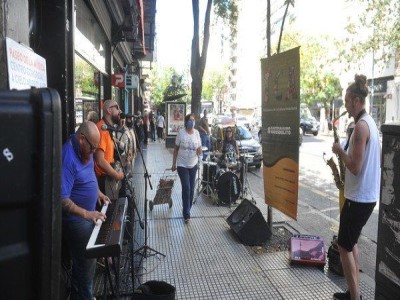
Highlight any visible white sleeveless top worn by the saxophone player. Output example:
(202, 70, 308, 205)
(344, 115, 381, 203)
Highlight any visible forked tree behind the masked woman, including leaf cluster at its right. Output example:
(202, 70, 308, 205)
(190, 0, 237, 119)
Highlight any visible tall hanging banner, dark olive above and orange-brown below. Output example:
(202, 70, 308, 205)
(261, 48, 300, 219)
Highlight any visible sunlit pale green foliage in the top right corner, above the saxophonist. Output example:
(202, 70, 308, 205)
(341, 0, 400, 67)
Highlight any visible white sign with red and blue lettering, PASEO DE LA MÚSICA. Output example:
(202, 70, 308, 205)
(6, 38, 47, 90)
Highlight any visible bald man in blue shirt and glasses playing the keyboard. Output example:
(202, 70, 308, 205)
(61, 121, 109, 300)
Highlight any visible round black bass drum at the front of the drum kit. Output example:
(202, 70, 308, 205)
(215, 169, 241, 204)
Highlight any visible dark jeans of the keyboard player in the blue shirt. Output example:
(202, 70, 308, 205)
(63, 219, 96, 300)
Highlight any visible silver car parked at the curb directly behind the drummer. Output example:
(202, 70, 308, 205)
(211, 124, 262, 168)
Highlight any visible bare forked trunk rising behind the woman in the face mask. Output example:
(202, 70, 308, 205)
(190, 0, 212, 120)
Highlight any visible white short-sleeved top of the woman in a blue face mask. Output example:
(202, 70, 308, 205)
(175, 128, 201, 168)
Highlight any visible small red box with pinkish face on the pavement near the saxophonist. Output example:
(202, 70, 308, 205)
(289, 234, 325, 266)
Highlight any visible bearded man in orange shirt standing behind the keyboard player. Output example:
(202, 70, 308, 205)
(94, 100, 124, 199)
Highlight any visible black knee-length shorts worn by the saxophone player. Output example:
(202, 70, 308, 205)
(338, 199, 376, 252)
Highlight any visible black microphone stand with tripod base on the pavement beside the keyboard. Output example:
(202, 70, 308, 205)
(132, 125, 166, 258)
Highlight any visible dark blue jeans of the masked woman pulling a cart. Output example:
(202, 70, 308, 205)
(177, 165, 197, 219)
